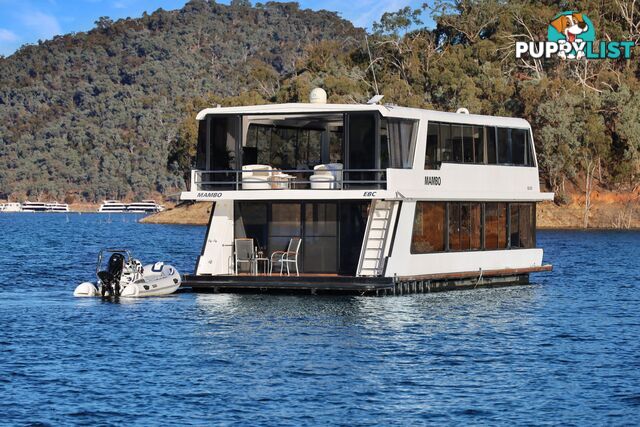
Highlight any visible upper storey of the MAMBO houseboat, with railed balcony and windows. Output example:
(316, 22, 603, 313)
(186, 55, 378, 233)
(181, 104, 552, 201)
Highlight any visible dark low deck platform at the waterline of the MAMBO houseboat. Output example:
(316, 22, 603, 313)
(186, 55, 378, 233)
(182, 265, 552, 295)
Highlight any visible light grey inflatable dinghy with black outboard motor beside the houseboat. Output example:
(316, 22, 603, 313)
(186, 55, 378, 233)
(73, 249, 181, 298)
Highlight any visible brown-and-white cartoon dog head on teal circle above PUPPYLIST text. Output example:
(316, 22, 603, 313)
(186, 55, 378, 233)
(547, 11, 596, 59)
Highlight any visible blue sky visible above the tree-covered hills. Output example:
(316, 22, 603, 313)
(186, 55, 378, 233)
(0, 0, 436, 56)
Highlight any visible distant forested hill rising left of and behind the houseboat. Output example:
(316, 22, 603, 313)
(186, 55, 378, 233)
(0, 0, 363, 201)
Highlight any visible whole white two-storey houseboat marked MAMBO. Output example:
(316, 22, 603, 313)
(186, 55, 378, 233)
(181, 90, 553, 295)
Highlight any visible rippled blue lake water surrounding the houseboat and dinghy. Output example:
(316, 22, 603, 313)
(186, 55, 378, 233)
(0, 214, 640, 426)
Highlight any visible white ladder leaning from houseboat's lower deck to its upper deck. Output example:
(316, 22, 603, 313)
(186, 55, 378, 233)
(358, 200, 398, 276)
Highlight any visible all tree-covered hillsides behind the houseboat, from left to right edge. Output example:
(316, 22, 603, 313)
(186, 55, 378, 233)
(0, 0, 640, 221)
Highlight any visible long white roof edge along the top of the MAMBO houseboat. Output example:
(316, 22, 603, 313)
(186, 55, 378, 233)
(196, 103, 530, 128)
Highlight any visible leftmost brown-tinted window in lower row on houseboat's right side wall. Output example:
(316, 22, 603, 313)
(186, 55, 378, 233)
(411, 202, 446, 254)
